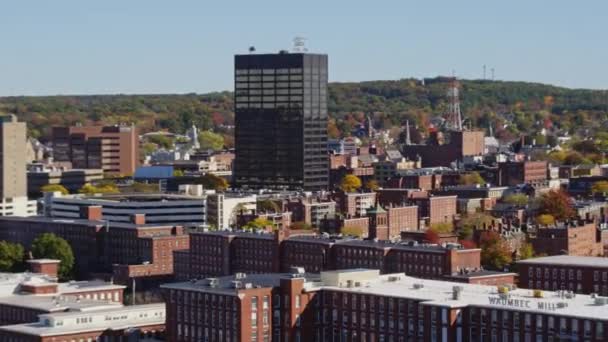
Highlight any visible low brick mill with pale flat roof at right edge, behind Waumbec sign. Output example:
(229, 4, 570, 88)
(517, 255, 608, 296)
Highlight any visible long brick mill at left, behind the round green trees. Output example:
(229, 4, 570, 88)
(0, 207, 189, 283)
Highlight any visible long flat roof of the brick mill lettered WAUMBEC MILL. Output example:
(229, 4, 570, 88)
(162, 269, 608, 321)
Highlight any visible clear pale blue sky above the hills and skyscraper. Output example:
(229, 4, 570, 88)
(0, 0, 608, 96)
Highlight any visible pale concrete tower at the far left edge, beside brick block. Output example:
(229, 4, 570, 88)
(0, 114, 36, 216)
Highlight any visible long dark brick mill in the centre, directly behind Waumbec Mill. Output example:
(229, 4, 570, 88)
(174, 232, 513, 283)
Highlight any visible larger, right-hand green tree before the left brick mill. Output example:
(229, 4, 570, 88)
(32, 233, 74, 280)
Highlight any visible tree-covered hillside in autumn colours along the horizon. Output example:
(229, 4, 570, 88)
(0, 77, 608, 145)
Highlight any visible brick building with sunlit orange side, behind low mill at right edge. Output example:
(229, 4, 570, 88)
(530, 220, 605, 256)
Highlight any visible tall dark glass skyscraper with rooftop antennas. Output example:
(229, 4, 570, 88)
(234, 52, 329, 190)
